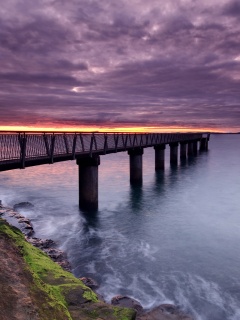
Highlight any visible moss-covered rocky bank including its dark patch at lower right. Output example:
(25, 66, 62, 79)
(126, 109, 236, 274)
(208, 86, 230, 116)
(0, 219, 135, 320)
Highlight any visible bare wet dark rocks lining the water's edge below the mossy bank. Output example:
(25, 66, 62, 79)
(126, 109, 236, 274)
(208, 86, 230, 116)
(0, 200, 194, 320)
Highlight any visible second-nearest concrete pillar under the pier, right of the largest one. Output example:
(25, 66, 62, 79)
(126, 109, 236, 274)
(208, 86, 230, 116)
(128, 148, 143, 184)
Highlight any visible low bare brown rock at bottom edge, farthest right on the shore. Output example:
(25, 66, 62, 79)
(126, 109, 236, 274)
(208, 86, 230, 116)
(136, 304, 194, 320)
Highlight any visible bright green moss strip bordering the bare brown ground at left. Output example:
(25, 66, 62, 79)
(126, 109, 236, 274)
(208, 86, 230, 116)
(0, 219, 72, 320)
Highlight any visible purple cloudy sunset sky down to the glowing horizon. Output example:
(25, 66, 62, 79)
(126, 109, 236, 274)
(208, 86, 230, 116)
(0, 0, 240, 132)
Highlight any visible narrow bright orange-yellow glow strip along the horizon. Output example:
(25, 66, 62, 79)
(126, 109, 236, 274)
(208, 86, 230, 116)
(0, 125, 232, 133)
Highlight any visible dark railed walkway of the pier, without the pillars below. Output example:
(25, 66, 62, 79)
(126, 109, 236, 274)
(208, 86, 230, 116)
(0, 132, 202, 171)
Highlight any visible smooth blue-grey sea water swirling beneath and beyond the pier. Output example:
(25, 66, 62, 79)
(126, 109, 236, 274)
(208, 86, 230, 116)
(0, 135, 240, 320)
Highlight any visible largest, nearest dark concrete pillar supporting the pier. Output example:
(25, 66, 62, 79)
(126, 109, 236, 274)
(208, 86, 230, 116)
(77, 156, 100, 210)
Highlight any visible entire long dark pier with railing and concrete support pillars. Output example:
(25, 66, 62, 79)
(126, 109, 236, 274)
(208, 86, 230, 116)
(0, 132, 210, 210)
